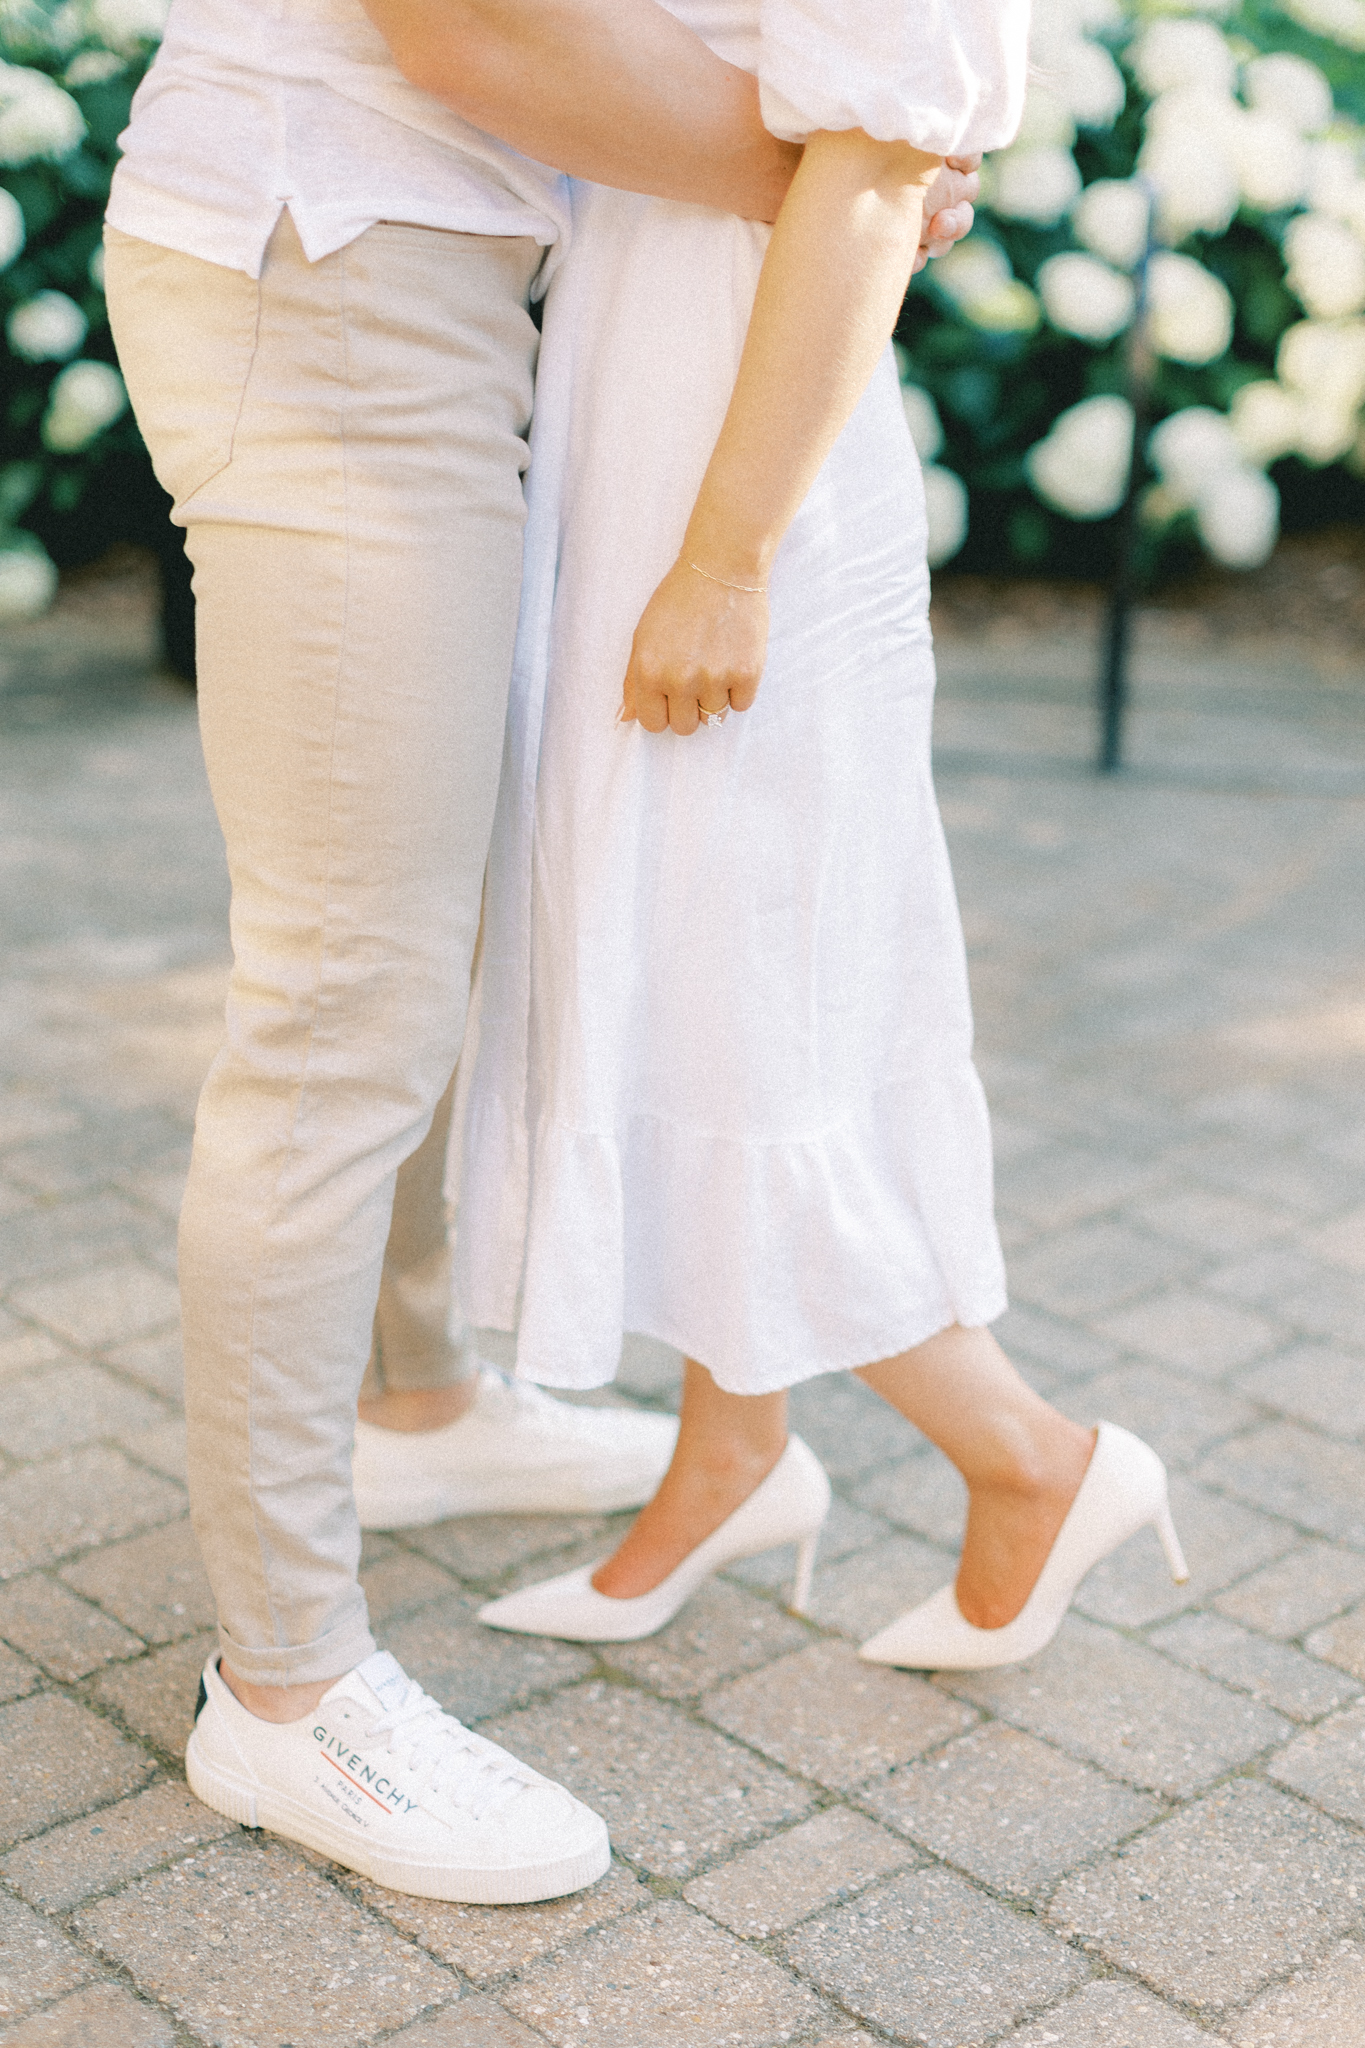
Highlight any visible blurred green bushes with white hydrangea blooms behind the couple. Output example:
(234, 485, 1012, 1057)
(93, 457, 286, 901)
(0, 0, 1365, 638)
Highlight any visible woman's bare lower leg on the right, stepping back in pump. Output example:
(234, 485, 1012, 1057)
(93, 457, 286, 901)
(857, 1325, 1095, 1628)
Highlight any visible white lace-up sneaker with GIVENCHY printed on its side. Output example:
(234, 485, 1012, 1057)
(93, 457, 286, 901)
(184, 1651, 612, 1907)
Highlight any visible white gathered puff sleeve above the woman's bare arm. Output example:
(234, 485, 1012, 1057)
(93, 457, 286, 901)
(759, 0, 1029, 156)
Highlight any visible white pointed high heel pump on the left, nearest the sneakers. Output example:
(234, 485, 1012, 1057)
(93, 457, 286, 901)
(470, 1436, 829, 1642)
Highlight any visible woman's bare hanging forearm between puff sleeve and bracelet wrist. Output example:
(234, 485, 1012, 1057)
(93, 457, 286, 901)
(684, 129, 941, 584)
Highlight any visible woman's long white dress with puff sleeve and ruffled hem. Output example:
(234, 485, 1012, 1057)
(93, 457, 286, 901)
(456, 0, 1023, 1393)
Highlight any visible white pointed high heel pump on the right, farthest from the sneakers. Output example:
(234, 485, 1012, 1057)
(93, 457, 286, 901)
(857, 1421, 1189, 1671)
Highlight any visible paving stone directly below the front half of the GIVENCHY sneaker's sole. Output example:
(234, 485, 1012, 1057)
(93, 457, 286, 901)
(351, 1864, 651, 1985)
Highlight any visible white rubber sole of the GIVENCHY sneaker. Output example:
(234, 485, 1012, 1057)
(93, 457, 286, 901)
(184, 1729, 612, 1907)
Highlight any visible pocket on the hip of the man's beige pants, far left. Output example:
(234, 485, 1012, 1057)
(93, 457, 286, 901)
(104, 227, 260, 524)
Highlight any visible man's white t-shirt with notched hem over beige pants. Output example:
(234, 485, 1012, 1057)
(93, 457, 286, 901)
(108, 0, 569, 276)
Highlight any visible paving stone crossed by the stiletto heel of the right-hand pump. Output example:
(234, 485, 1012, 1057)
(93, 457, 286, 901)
(1076, 1473, 1295, 1628)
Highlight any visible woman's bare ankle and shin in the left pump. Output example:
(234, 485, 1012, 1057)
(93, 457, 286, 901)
(591, 1358, 786, 1599)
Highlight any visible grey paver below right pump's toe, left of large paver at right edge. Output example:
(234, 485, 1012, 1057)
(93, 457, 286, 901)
(864, 1722, 1160, 1896)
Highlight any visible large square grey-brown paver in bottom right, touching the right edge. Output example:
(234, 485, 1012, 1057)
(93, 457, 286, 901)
(1050, 1778, 1365, 2011)
